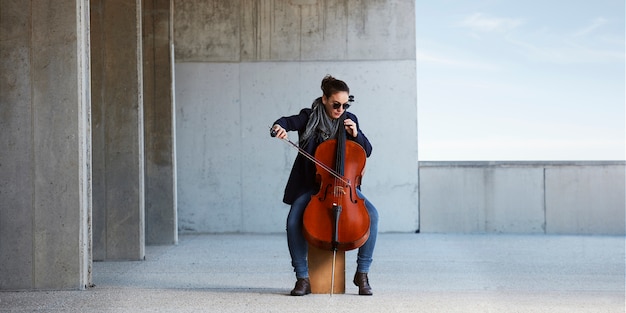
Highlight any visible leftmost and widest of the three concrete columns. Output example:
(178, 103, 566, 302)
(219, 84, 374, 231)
(0, 0, 91, 290)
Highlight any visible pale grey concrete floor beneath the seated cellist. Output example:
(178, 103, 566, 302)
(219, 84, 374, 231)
(0, 234, 625, 313)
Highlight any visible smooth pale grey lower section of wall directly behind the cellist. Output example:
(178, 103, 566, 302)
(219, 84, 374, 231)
(176, 60, 418, 233)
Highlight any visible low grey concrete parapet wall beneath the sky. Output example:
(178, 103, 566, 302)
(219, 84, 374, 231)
(419, 161, 626, 235)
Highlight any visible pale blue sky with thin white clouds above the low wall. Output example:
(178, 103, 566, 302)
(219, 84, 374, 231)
(416, 0, 626, 161)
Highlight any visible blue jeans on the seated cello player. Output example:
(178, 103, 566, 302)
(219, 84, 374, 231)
(287, 189, 378, 278)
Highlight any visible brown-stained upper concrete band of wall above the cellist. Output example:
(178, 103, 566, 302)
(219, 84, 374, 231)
(174, 0, 416, 62)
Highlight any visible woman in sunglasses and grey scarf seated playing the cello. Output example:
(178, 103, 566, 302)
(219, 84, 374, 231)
(272, 75, 378, 296)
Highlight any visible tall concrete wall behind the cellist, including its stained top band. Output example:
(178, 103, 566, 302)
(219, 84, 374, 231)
(174, 0, 418, 232)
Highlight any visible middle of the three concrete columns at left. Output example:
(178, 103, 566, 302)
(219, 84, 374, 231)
(91, 0, 145, 260)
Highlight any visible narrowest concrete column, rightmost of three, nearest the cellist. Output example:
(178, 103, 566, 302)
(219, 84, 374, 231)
(142, 0, 178, 244)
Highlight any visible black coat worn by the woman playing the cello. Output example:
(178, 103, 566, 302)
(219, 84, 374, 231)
(274, 108, 372, 204)
